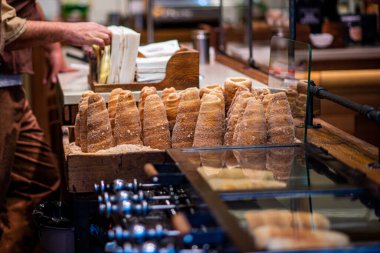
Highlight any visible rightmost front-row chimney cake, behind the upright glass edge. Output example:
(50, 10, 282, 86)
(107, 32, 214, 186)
(266, 92, 295, 144)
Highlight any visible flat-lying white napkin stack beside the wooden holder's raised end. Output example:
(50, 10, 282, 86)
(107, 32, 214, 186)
(136, 40, 180, 82)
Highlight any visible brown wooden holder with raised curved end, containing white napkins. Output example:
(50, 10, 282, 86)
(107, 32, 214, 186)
(89, 48, 199, 92)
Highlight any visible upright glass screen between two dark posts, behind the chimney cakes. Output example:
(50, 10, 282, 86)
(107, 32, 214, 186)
(219, 0, 289, 68)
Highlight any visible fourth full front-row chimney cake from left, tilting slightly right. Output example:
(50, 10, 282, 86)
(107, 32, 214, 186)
(172, 88, 201, 148)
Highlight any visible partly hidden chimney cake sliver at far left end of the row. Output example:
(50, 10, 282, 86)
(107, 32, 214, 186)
(76, 91, 94, 152)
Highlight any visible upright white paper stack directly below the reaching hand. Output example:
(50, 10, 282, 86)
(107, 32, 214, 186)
(107, 26, 140, 84)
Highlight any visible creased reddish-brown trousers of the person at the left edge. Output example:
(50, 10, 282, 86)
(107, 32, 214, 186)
(0, 86, 60, 253)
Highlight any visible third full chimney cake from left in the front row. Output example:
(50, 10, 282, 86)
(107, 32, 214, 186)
(143, 94, 170, 150)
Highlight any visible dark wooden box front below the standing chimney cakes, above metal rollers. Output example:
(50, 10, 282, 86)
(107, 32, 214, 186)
(62, 126, 170, 193)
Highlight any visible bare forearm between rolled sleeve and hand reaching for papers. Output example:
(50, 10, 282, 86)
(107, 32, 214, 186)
(5, 21, 68, 50)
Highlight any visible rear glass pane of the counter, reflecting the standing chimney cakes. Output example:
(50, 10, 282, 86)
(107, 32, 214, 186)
(171, 146, 353, 193)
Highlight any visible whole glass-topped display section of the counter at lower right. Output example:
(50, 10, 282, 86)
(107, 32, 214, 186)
(169, 144, 380, 252)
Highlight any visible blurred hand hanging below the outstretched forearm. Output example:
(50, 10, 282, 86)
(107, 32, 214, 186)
(43, 43, 76, 88)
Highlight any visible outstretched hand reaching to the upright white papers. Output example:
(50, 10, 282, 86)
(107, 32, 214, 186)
(63, 22, 112, 48)
